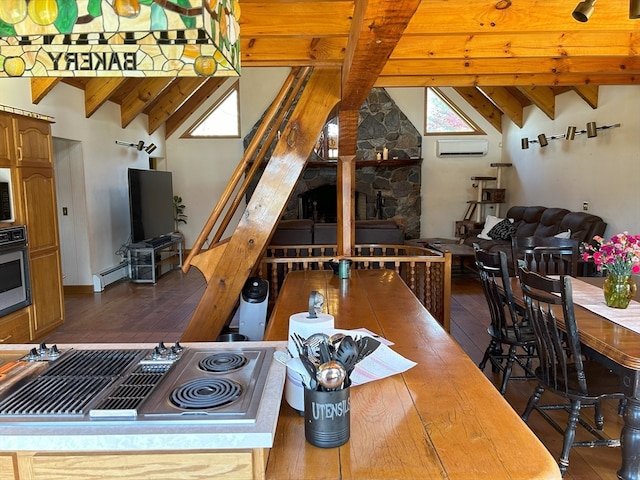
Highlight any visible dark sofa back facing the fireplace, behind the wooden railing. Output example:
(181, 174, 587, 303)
(270, 219, 405, 245)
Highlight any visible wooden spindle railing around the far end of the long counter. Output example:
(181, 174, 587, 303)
(257, 244, 451, 332)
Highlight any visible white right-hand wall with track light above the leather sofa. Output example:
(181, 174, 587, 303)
(503, 86, 640, 236)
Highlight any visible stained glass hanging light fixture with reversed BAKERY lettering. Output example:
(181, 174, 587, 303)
(0, 0, 240, 77)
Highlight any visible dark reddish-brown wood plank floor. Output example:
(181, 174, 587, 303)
(44, 269, 622, 480)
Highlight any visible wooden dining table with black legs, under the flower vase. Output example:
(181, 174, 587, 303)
(511, 277, 640, 480)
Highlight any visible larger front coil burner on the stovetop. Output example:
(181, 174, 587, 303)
(171, 378, 242, 410)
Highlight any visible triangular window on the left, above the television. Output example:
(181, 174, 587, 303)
(182, 82, 240, 138)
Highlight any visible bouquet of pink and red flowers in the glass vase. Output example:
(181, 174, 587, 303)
(582, 232, 640, 276)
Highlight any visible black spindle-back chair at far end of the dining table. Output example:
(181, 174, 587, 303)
(511, 237, 580, 277)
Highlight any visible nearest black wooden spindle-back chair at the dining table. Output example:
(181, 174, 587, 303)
(519, 268, 624, 475)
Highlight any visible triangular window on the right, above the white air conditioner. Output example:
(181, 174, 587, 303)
(424, 87, 485, 135)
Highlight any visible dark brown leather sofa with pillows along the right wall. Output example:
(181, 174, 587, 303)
(464, 206, 607, 273)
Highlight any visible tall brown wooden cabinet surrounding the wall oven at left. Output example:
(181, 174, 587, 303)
(0, 113, 64, 343)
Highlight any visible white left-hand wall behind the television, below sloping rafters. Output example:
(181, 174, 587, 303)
(0, 78, 164, 285)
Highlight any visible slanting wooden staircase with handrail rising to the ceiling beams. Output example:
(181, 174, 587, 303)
(181, 68, 340, 342)
